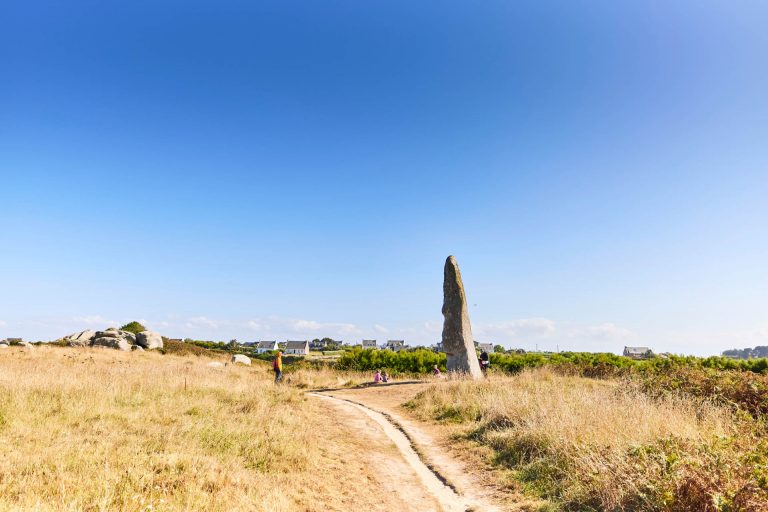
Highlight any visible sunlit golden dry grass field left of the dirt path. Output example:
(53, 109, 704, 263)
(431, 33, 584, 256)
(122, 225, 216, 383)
(0, 347, 408, 511)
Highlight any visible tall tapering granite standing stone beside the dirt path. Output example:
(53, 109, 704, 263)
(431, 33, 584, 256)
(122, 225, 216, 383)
(443, 256, 483, 379)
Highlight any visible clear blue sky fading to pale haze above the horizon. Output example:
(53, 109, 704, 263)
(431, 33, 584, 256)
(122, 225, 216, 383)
(0, 1, 768, 354)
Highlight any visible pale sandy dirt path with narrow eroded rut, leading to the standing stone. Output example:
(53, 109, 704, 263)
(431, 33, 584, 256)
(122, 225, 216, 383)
(310, 383, 503, 512)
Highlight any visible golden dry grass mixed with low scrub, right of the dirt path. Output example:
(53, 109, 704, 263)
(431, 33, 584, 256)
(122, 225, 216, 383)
(409, 369, 768, 511)
